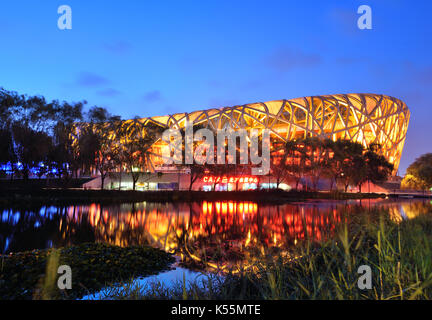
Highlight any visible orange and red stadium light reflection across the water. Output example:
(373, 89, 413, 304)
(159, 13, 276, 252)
(59, 199, 430, 270)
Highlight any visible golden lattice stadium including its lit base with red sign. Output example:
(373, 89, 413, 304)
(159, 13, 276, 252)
(74, 93, 410, 190)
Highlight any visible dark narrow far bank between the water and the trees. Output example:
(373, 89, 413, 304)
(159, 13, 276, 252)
(0, 188, 385, 205)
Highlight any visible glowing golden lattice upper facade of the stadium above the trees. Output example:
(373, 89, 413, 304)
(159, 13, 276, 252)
(76, 94, 410, 191)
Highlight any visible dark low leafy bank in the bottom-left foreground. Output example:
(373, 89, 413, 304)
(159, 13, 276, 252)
(0, 243, 174, 300)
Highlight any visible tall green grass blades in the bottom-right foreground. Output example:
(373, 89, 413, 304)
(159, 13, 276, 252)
(98, 209, 432, 299)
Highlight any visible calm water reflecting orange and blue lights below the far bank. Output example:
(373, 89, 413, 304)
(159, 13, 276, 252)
(0, 199, 432, 268)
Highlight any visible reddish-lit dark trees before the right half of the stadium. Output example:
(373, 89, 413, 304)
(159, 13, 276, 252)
(271, 137, 394, 192)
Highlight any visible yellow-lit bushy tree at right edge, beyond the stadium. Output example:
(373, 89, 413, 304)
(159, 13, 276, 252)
(401, 153, 432, 190)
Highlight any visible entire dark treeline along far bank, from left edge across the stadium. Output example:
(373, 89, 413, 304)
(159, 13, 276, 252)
(0, 88, 393, 191)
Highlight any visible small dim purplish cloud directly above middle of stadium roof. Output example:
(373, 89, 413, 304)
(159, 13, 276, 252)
(266, 48, 321, 71)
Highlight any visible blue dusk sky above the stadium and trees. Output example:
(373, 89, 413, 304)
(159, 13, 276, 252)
(0, 0, 432, 174)
